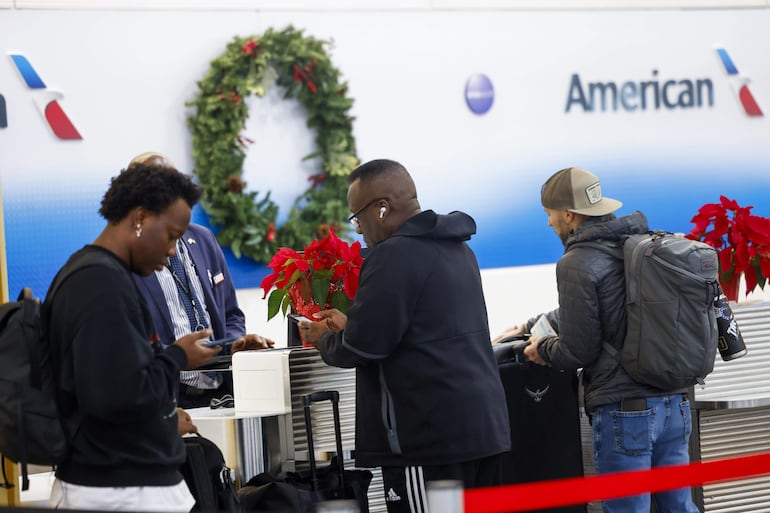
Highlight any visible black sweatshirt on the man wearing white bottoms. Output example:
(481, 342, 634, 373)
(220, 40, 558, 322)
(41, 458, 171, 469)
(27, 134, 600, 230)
(44, 246, 187, 487)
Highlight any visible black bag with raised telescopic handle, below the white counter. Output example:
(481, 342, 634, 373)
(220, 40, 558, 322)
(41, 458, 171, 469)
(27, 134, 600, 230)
(238, 390, 372, 513)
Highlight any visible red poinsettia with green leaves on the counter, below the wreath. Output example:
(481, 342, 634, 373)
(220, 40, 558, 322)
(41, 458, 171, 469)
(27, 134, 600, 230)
(260, 228, 363, 320)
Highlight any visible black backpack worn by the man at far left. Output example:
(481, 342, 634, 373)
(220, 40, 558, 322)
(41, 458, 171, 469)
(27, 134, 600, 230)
(0, 252, 119, 490)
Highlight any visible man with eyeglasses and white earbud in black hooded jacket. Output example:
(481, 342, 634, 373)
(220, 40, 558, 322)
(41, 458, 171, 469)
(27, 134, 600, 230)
(299, 160, 510, 513)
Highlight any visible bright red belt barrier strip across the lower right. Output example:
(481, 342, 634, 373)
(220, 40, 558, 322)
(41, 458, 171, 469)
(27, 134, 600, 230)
(464, 453, 770, 513)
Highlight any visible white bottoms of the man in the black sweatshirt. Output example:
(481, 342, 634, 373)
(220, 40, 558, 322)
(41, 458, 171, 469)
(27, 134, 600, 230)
(48, 479, 195, 513)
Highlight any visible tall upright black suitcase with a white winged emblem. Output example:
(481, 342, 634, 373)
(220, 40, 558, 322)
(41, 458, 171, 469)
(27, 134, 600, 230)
(493, 337, 586, 513)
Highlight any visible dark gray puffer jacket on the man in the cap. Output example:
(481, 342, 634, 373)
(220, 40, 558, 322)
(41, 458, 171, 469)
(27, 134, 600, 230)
(527, 212, 678, 412)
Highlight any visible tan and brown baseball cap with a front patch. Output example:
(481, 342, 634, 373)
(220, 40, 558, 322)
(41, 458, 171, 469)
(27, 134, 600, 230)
(540, 167, 623, 216)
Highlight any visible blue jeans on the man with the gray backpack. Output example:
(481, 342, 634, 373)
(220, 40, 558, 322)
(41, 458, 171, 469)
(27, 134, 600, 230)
(591, 394, 698, 513)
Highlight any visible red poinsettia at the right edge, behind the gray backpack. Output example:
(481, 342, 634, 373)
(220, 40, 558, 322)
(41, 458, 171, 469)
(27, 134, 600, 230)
(687, 196, 770, 301)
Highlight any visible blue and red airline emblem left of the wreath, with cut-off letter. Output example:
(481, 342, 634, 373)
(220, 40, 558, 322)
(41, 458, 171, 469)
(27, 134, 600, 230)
(0, 53, 83, 140)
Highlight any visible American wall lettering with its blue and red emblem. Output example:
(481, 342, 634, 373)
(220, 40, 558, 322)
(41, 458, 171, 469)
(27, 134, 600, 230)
(565, 48, 763, 117)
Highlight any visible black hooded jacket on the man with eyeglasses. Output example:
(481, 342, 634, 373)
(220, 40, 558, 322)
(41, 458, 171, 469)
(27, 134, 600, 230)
(320, 210, 510, 467)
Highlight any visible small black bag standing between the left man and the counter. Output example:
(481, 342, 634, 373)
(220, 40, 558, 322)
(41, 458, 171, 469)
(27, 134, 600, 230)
(179, 435, 241, 513)
